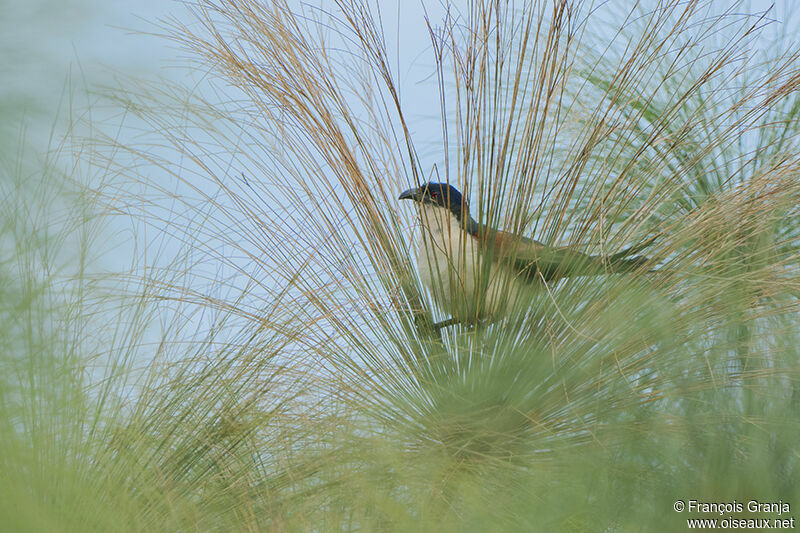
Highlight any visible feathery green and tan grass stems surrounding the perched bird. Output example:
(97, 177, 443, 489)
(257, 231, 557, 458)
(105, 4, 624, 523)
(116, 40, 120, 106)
(0, 2, 800, 531)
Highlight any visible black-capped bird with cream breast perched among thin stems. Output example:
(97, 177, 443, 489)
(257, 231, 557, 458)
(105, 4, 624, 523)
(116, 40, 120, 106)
(398, 182, 654, 331)
